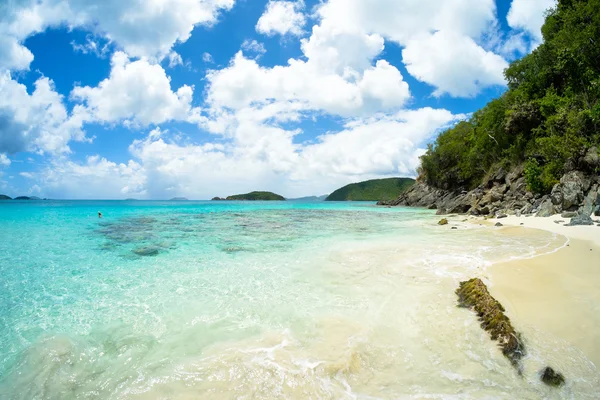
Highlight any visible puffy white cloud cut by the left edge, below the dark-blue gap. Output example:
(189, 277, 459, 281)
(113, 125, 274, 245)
(0, 72, 85, 154)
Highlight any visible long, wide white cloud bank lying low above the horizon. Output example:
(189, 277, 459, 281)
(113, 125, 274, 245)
(34, 107, 465, 199)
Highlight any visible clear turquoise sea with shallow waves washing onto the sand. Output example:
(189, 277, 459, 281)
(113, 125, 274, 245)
(0, 201, 600, 399)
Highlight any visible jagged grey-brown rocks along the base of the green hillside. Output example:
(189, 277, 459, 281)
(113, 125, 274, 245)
(378, 166, 600, 221)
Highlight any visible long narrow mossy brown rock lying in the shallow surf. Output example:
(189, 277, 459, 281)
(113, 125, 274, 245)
(456, 278, 525, 367)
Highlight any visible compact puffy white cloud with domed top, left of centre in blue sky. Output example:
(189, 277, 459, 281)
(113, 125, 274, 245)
(71, 52, 200, 126)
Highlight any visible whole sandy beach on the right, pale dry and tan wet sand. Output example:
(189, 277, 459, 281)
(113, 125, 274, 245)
(487, 215, 600, 366)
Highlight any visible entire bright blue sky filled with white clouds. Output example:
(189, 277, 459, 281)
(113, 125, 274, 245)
(0, 0, 555, 199)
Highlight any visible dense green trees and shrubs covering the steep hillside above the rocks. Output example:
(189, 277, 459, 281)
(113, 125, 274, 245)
(420, 0, 600, 193)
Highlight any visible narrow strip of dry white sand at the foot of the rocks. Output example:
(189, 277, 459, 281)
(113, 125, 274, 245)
(488, 214, 600, 247)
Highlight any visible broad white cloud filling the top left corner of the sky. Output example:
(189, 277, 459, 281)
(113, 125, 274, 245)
(0, 0, 235, 69)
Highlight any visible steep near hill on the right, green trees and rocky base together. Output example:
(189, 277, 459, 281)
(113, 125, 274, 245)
(382, 0, 600, 220)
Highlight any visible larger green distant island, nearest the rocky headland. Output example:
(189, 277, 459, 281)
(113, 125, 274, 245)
(325, 178, 415, 201)
